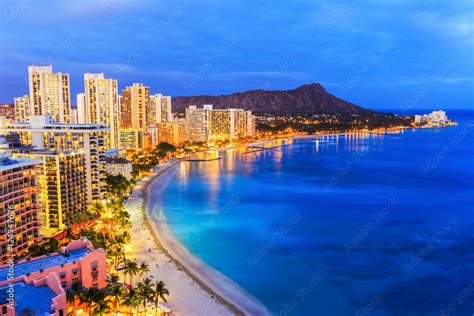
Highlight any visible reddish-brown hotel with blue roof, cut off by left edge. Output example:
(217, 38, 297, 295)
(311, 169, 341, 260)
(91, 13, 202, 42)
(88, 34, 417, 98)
(0, 153, 42, 263)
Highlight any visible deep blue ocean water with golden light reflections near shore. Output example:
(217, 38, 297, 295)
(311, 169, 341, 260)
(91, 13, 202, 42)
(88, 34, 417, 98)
(149, 112, 474, 315)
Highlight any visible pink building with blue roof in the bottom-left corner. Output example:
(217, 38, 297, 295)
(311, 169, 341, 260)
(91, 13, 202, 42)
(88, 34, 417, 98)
(0, 240, 107, 316)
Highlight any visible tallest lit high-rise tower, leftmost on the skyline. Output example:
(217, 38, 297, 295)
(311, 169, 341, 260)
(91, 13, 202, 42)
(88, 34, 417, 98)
(28, 65, 71, 123)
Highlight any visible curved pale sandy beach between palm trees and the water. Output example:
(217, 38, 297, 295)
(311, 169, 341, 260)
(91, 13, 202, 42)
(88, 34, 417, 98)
(126, 161, 270, 315)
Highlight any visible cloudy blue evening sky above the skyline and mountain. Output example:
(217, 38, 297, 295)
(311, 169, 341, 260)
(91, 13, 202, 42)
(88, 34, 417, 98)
(0, 0, 474, 110)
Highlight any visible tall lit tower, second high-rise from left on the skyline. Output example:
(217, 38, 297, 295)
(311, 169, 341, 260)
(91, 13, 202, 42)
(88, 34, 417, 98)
(78, 73, 119, 148)
